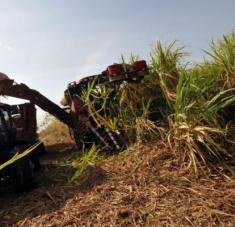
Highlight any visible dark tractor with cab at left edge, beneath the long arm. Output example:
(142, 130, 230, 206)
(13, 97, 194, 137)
(0, 103, 45, 192)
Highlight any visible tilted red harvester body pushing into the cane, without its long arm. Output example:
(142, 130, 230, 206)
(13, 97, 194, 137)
(61, 60, 148, 151)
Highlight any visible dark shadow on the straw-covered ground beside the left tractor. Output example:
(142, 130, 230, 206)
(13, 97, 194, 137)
(0, 144, 107, 226)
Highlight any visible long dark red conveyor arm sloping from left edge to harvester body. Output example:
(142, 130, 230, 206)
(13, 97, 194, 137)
(0, 80, 74, 128)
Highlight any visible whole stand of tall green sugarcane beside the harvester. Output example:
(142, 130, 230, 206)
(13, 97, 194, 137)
(72, 33, 235, 177)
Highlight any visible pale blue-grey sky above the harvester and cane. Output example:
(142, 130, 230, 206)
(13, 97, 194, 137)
(0, 0, 235, 121)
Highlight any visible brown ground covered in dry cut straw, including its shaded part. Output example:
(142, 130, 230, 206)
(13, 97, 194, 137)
(0, 137, 235, 227)
